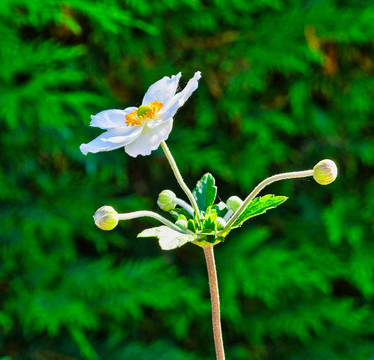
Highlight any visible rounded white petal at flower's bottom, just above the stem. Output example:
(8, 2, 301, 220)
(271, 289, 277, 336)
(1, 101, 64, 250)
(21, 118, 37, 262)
(125, 118, 173, 157)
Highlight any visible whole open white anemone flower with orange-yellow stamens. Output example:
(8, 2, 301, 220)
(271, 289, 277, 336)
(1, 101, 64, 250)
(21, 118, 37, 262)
(80, 71, 201, 157)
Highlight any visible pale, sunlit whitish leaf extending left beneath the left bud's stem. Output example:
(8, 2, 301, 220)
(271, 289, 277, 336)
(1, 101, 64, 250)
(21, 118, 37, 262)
(138, 226, 196, 250)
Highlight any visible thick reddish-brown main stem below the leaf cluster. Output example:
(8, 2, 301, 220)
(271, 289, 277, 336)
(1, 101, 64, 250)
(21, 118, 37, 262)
(204, 245, 225, 360)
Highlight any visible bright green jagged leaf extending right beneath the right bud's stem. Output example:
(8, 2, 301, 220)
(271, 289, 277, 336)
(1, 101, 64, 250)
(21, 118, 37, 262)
(232, 194, 288, 228)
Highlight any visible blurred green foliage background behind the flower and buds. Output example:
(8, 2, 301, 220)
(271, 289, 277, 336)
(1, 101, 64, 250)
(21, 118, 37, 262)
(0, 0, 374, 360)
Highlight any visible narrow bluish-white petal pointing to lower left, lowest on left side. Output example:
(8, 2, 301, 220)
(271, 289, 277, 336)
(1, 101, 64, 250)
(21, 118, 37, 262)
(80, 125, 144, 155)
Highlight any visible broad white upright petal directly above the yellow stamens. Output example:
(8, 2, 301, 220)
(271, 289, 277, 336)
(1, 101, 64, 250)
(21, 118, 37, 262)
(142, 73, 182, 104)
